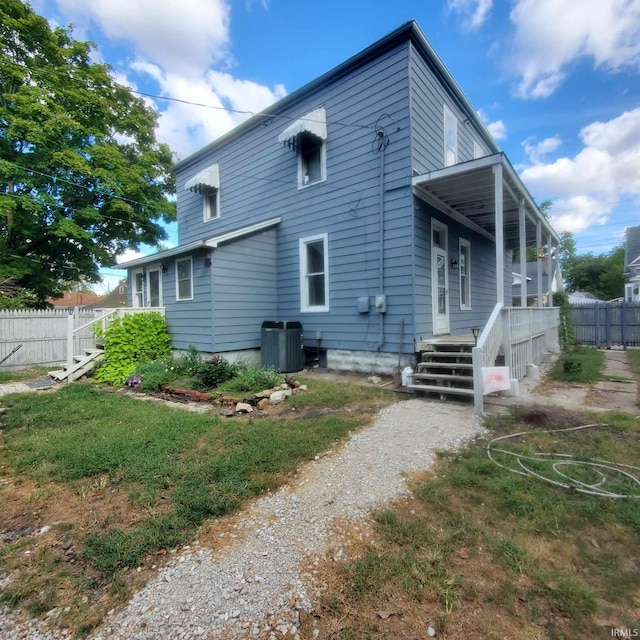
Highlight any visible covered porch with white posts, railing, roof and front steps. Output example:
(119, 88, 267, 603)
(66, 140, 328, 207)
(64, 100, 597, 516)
(412, 153, 560, 412)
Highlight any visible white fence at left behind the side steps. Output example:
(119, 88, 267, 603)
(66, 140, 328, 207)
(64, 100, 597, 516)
(0, 307, 164, 371)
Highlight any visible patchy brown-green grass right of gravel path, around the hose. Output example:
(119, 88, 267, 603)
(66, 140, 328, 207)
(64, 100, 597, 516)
(302, 407, 640, 640)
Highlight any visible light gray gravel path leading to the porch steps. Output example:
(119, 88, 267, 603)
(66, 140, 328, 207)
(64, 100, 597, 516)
(0, 399, 482, 640)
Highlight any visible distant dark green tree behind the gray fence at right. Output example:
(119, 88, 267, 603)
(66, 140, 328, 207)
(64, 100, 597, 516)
(564, 245, 624, 300)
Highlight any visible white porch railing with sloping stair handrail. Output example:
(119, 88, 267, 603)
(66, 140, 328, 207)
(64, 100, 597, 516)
(473, 303, 560, 413)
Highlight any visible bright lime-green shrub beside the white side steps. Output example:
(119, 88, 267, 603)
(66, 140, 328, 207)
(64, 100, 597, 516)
(96, 312, 171, 386)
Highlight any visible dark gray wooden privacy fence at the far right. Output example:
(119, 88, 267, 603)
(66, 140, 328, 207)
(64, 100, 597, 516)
(569, 302, 640, 347)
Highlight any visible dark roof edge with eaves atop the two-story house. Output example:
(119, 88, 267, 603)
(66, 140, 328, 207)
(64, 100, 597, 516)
(174, 20, 500, 171)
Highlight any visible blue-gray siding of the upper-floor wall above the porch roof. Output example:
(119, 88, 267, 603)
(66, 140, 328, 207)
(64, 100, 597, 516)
(411, 41, 490, 174)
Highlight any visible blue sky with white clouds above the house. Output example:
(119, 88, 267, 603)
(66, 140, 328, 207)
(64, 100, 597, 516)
(32, 0, 640, 286)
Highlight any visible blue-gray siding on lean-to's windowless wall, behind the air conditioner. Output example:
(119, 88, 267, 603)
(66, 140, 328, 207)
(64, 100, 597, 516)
(212, 229, 278, 352)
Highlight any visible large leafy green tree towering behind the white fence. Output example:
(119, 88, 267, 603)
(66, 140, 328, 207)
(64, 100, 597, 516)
(0, 0, 175, 306)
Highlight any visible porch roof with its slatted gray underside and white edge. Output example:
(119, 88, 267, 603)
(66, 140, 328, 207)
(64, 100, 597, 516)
(412, 153, 559, 248)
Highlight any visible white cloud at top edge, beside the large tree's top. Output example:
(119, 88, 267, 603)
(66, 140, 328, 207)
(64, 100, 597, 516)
(57, 0, 231, 77)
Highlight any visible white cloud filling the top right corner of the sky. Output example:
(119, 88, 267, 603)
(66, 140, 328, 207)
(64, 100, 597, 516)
(509, 0, 640, 98)
